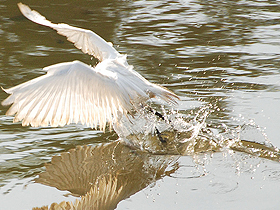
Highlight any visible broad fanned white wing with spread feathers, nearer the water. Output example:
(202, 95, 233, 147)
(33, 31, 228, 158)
(2, 61, 135, 130)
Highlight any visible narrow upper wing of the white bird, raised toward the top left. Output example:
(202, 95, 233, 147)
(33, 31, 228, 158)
(18, 3, 119, 61)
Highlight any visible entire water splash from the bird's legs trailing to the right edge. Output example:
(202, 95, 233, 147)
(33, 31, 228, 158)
(114, 105, 280, 161)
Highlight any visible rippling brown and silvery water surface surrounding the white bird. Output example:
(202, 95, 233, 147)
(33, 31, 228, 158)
(0, 0, 280, 209)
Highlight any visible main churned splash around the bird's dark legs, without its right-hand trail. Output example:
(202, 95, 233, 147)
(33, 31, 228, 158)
(111, 106, 210, 154)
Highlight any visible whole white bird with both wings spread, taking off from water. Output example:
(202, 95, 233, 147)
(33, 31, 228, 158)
(2, 3, 179, 131)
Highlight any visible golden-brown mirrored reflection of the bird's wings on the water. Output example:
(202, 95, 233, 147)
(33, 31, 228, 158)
(34, 141, 178, 209)
